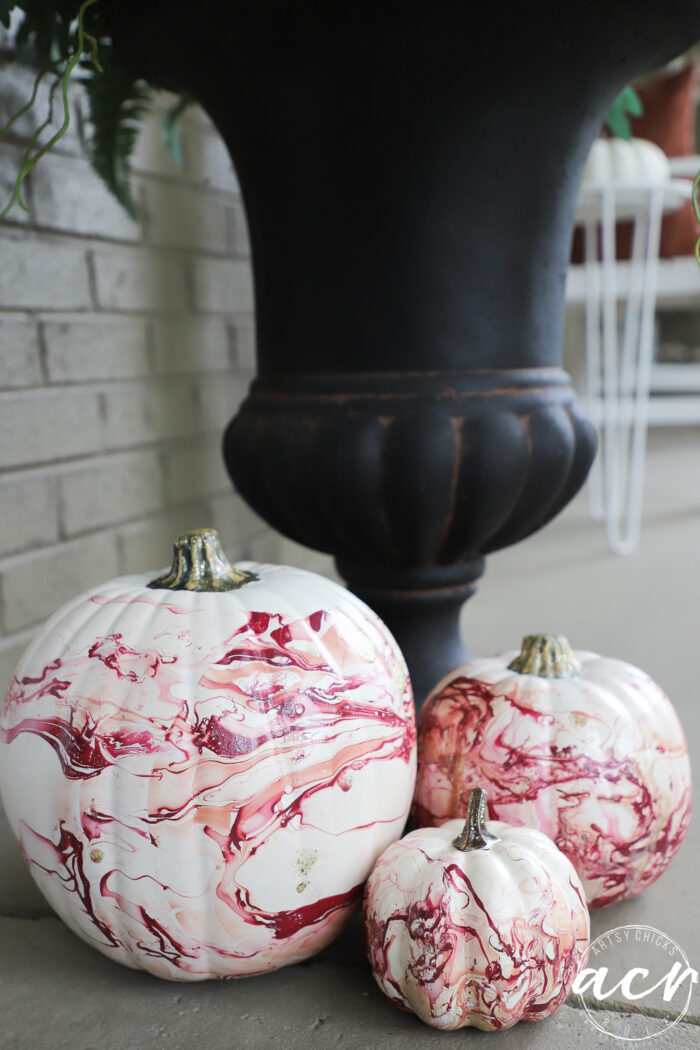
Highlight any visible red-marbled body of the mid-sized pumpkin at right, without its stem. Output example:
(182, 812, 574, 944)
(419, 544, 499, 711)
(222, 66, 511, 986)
(412, 652, 691, 907)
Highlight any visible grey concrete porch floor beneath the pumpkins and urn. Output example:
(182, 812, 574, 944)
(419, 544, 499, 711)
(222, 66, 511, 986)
(0, 429, 700, 1050)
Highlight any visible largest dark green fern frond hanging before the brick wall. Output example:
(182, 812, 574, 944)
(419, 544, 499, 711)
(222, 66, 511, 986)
(83, 57, 153, 218)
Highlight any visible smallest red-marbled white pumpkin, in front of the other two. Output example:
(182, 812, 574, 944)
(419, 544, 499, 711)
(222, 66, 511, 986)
(363, 789, 590, 1031)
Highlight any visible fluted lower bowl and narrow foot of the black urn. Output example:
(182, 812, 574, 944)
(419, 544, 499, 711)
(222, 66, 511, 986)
(225, 369, 595, 704)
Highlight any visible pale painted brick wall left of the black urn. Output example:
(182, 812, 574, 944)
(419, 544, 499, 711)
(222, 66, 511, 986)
(0, 69, 333, 912)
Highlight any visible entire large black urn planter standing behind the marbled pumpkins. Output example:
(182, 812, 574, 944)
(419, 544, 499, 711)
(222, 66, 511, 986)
(115, 0, 700, 702)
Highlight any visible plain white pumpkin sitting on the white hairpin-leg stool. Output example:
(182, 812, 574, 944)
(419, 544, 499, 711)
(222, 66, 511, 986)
(581, 138, 671, 189)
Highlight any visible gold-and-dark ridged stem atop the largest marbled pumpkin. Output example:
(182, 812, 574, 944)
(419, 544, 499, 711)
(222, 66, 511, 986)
(148, 528, 260, 591)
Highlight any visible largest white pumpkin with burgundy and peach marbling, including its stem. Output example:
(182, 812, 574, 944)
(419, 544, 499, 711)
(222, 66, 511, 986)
(0, 530, 416, 980)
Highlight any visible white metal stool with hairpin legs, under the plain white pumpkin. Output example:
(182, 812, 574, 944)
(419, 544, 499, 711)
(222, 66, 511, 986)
(579, 183, 687, 554)
